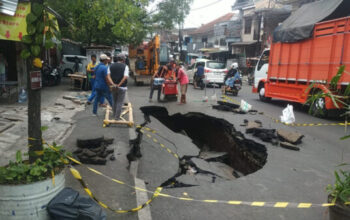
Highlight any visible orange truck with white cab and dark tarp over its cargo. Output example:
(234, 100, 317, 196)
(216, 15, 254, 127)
(253, 0, 350, 116)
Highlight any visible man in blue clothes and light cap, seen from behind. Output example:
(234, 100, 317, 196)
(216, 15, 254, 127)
(92, 54, 115, 115)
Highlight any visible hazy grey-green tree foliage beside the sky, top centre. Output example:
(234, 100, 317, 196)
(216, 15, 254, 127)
(153, 0, 193, 29)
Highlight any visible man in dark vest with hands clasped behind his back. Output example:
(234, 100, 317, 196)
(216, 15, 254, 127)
(109, 53, 129, 120)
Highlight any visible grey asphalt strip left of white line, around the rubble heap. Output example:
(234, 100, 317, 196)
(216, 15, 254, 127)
(63, 106, 138, 219)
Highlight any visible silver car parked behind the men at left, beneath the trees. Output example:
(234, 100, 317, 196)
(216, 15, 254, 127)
(58, 55, 88, 76)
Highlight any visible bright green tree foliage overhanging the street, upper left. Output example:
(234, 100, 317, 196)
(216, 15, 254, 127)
(48, 0, 150, 45)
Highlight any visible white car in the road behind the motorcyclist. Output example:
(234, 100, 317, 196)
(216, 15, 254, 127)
(187, 59, 228, 85)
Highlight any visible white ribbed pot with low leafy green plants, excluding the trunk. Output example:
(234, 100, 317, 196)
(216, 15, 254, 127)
(0, 144, 68, 219)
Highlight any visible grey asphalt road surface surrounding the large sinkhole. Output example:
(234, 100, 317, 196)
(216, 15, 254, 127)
(128, 83, 350, 220)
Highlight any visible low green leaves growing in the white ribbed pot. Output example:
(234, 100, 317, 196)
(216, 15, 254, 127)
(0, 144, 67, 184)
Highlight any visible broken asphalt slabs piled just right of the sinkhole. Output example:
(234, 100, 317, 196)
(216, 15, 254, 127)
(242, 120, 304, 151)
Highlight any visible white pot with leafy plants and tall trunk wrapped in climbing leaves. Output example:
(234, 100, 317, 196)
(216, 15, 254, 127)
(0, 0, 67, 220)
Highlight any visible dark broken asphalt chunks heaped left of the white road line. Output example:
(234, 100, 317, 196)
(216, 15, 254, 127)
(73, 137, 115, 165)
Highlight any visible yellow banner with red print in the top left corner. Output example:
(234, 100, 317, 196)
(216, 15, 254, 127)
(0, 2, 30, 41)
